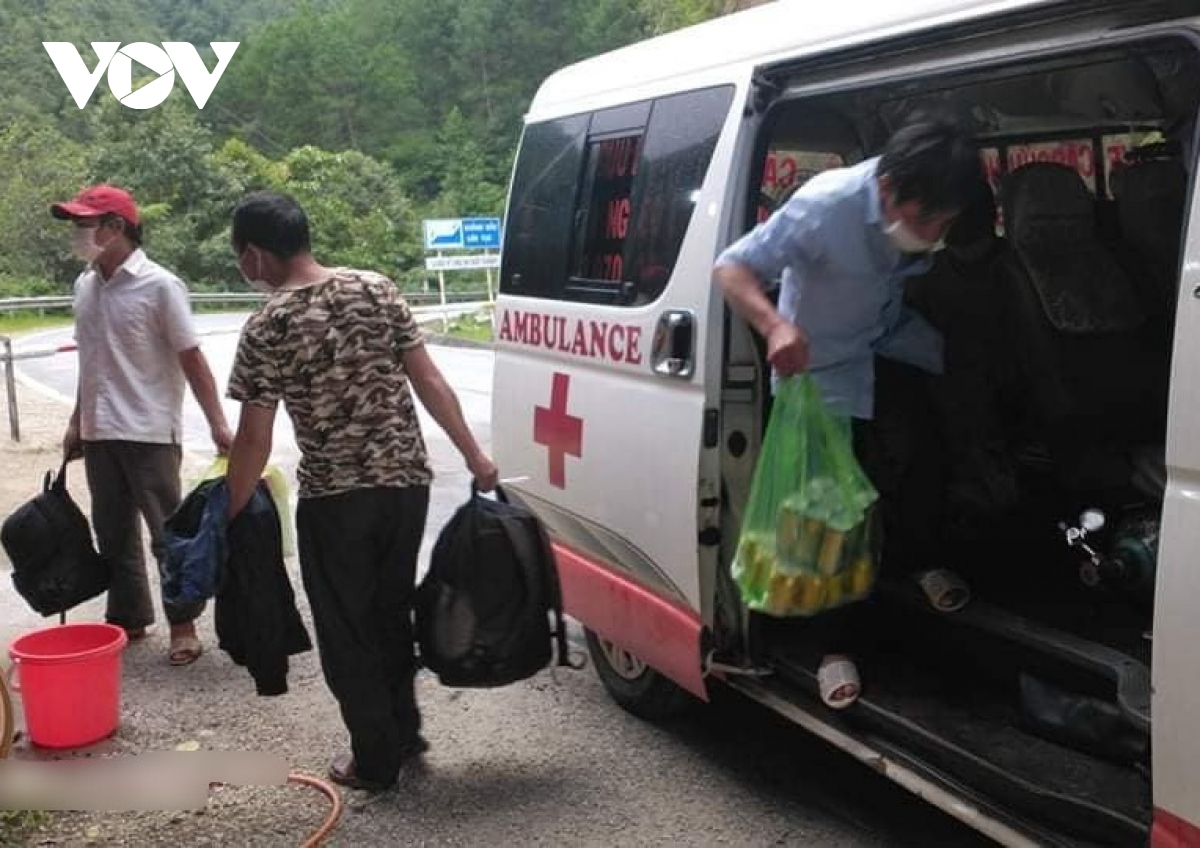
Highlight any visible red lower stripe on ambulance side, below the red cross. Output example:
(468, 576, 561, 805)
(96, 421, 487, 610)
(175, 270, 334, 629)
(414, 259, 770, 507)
(552, 542, 708, 700)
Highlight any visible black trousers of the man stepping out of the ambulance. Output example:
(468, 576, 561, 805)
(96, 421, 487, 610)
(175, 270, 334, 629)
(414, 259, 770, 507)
(809, 357, 950, 654)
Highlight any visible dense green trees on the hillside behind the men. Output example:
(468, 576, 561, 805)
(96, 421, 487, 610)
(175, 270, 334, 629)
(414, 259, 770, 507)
(0, 0, 737, 296)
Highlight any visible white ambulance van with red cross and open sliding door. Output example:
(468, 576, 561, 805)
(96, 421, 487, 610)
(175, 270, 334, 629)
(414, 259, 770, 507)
(492, 0, 1200, 846)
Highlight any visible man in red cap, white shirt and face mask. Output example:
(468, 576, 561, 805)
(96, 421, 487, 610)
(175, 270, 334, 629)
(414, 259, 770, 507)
(50, 185, 233, 666)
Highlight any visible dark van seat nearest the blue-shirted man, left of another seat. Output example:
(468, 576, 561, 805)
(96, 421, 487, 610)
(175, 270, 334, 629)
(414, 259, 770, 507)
(1001, 162, 1168, 491)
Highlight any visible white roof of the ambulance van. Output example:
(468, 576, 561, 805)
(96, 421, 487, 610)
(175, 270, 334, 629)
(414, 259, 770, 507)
(530, 0, 1062, 118)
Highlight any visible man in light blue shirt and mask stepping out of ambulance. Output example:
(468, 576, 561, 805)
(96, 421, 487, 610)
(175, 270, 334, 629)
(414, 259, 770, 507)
(715, 120, 982, 708)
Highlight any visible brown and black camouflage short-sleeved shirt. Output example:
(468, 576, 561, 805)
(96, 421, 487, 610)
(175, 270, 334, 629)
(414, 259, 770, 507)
(228, 269, 432, 498)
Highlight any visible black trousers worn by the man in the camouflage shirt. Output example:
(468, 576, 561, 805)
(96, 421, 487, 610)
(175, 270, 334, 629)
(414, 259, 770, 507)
(296, 486, 430, 783)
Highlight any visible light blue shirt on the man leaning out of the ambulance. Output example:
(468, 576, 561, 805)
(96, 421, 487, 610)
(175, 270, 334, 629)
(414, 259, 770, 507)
(716, 158, 942, 419)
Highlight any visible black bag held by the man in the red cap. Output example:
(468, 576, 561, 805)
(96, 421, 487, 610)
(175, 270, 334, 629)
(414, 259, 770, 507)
(0, 461, 112, 615)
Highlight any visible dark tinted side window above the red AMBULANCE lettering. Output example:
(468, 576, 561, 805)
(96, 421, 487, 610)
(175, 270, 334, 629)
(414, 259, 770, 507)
(500, 85, 733, 306)
